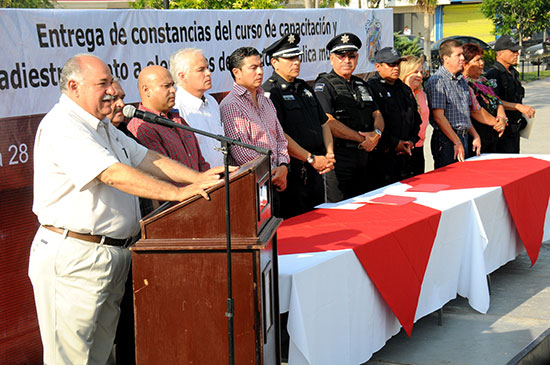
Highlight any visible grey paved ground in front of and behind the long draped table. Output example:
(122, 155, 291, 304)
(366, 79, 550, 365)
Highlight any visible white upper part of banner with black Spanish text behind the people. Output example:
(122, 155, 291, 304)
(0, 9, 393, 118)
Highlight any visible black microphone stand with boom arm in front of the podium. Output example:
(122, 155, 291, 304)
(135, 111, 273, 365)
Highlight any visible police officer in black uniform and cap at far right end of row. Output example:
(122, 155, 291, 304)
(485, 35, 535, 153)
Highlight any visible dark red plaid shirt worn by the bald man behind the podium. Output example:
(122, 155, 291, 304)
(128, 103, 210, 171)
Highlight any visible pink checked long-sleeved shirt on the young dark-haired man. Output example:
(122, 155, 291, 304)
(220, 83, 290, 167)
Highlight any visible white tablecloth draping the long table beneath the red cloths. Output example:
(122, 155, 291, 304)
(279, 155, 550, 365)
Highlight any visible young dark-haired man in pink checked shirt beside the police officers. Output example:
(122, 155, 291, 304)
(220, 47, 290, 215)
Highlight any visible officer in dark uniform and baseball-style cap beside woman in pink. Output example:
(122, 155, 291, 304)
(367, 47, 422, 187)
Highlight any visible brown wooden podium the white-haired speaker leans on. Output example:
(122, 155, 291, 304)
(132, 157, 281, 365)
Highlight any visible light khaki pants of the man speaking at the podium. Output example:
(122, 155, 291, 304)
(29, 227, 131, 365)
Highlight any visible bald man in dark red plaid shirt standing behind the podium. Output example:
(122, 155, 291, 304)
(128, 65, 210, 172)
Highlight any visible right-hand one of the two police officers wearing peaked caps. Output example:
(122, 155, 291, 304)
(314, 33, 384, 202)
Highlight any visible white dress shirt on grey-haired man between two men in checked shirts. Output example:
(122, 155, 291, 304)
(174, 86, 224, 167)
